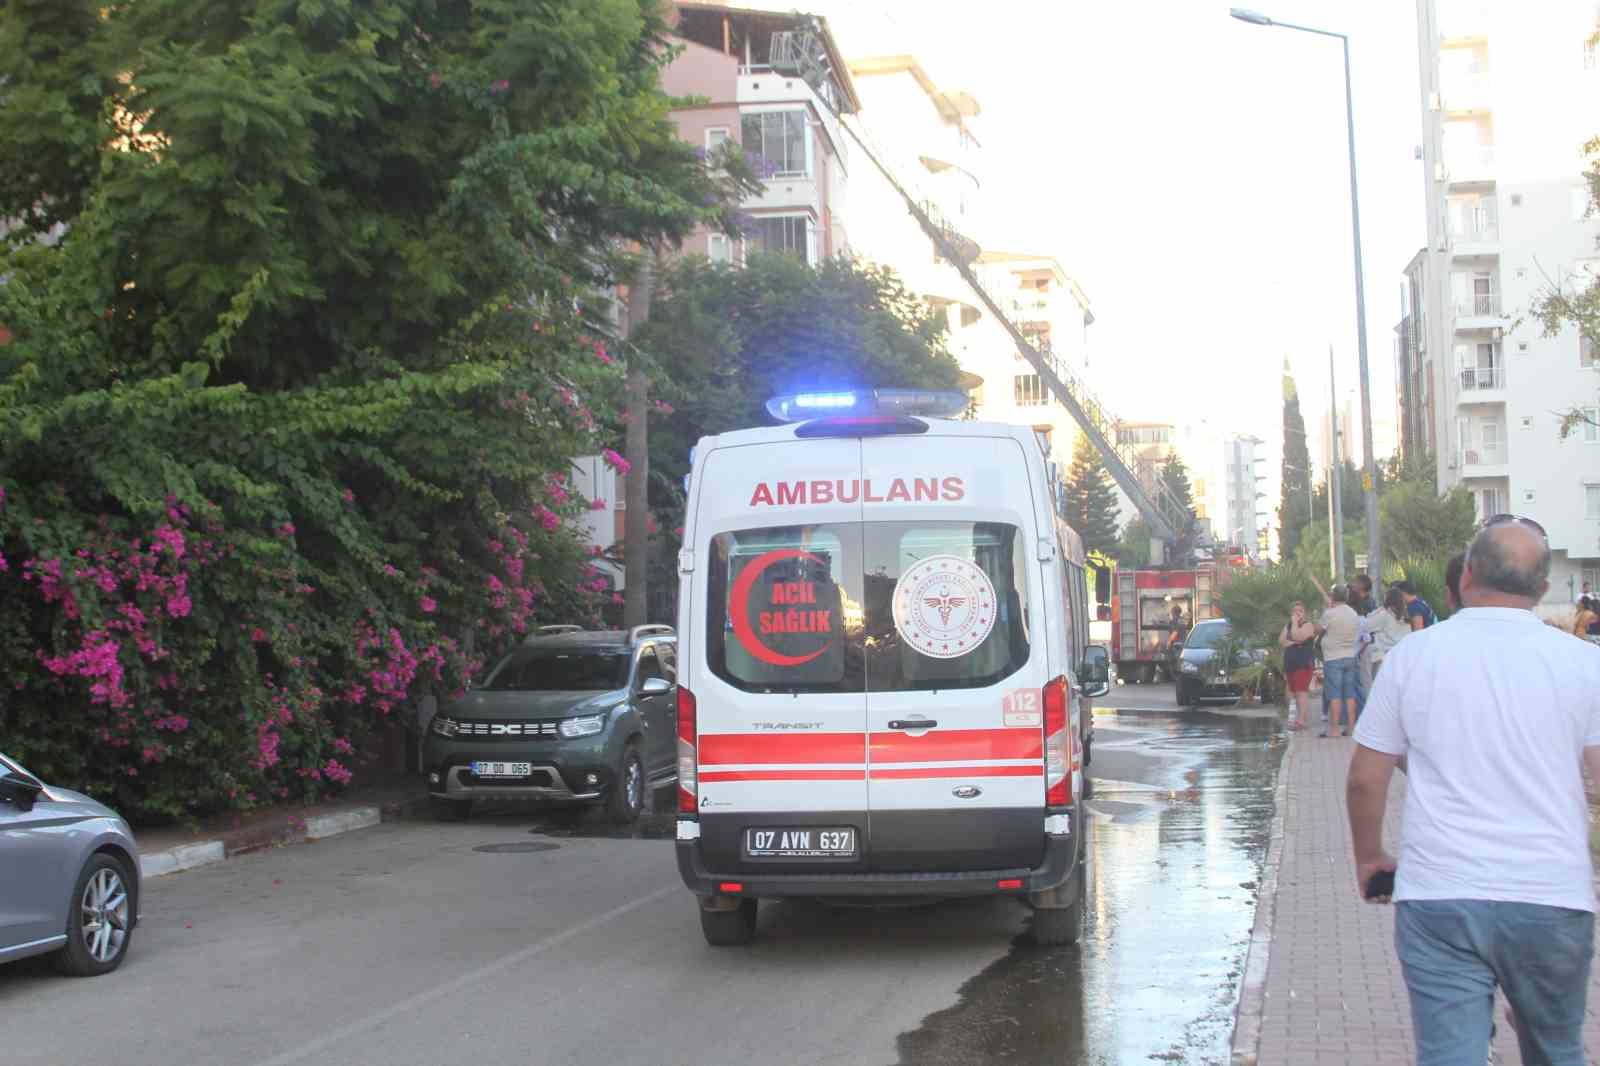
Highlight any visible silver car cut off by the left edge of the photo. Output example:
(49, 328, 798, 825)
(0, 754, 139, 976)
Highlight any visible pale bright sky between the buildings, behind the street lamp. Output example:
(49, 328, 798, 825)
(819, 0, 1426, 523)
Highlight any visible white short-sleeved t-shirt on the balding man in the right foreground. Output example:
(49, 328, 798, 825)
(1355, 607, 1600, 911)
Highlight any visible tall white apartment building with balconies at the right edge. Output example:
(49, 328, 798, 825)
(1397, 0, 1600, 603)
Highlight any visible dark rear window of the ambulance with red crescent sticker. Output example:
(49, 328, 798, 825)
(706, 522, 1030, 693)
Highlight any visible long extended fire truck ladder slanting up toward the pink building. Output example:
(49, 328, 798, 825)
(838, 114, 1189, 541)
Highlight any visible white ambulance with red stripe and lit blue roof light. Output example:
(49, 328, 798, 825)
(677, 389, 1107, 946)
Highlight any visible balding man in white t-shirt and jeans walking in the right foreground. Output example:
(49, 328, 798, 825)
(1346, 517, 1600, 1066)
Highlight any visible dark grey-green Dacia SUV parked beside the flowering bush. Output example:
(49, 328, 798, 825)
(422, 626, 678, 823)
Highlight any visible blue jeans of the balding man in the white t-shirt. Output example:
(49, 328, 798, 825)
(1395, 900, 1595, 1066)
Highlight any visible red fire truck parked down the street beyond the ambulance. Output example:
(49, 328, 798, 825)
(1110, 562, 1227, 685)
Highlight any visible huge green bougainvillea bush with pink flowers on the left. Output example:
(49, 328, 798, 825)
(0, 0, 736, 818)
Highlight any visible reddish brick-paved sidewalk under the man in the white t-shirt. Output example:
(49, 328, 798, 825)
(1234, 733, 1600, 1066)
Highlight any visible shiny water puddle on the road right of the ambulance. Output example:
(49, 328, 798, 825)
(898, 704, 1283, 1066)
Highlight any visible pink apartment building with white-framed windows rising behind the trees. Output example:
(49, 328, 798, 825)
(662, 0, 866, 262)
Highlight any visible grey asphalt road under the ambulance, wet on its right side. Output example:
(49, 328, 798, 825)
(0, 688, 1282, 1066)
